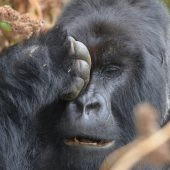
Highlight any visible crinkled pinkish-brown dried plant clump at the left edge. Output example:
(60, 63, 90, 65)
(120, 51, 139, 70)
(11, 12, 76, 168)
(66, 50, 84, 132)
(0, 6, 44, 51)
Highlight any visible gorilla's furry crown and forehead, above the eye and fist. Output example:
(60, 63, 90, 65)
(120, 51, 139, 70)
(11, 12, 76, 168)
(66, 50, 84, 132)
(60, 0, 166, 61)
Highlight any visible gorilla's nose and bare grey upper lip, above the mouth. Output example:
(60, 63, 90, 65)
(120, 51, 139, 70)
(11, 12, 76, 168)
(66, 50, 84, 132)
(62, 92, 116, 141)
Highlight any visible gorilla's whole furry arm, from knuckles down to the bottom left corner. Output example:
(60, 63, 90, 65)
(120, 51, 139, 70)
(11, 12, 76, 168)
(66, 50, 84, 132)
(0, 28, 90, 170)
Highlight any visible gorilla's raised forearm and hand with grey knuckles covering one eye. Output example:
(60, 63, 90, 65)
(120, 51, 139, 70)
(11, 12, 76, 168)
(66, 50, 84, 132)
(0, 26, 90, 117)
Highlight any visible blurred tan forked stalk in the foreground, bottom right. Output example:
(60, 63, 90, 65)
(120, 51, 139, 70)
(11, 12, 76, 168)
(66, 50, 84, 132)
(100, 104, 170, 170)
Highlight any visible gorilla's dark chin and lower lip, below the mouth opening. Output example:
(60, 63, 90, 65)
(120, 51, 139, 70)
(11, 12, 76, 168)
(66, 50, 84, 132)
(56, 142, 115, 170)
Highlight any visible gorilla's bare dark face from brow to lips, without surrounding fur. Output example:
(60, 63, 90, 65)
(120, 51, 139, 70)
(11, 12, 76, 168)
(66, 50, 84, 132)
(57, 26, 141, 143)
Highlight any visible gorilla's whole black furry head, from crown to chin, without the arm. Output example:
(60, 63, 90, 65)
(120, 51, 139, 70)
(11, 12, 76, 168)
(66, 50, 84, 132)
(37, 0, 167, 170)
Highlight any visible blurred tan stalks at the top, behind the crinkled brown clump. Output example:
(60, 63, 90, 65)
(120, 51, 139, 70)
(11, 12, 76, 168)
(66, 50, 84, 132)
(10, 0, 69, 29)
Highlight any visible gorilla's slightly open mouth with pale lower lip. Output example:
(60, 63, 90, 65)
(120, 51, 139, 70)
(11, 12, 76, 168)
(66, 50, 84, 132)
(64, 137, 114, 147)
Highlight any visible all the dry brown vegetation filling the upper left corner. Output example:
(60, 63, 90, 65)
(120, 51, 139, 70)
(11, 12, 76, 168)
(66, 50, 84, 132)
(0, 0, 69, 52)
